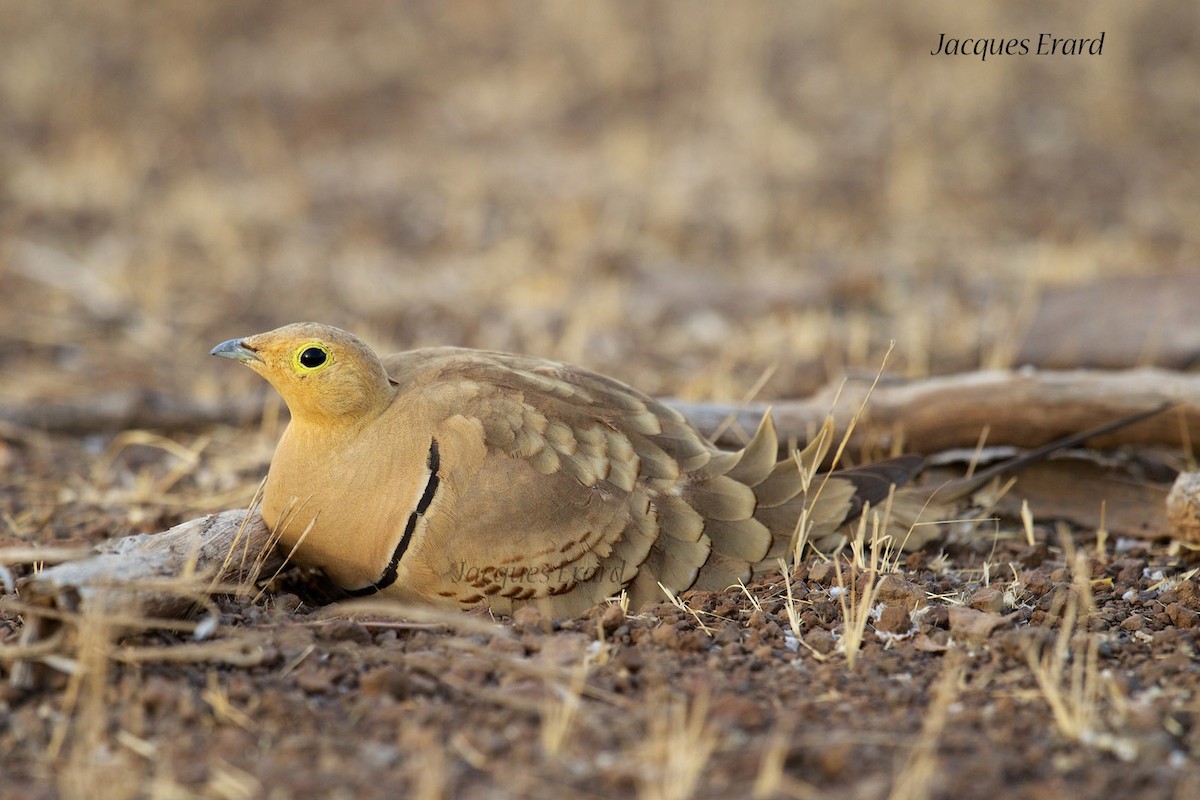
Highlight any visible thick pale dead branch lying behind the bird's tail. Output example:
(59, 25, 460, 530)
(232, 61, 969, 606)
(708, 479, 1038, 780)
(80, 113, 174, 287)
(668, 368, 1200, 455)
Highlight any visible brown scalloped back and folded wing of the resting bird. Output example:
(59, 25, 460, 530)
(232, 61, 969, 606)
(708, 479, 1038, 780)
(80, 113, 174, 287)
(364, 348, 916, 616)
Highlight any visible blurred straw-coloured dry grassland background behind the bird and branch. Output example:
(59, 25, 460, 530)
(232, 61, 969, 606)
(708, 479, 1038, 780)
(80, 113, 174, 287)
(0, 0, 1200, 405)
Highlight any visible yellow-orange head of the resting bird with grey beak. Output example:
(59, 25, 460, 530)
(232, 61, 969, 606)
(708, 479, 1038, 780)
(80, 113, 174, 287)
(211, 323, 394, 425)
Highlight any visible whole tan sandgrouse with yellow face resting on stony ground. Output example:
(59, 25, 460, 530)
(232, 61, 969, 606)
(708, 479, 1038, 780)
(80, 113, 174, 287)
(212, 324, 920, 616)
